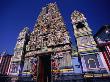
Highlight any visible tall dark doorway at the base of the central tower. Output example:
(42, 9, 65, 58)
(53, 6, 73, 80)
(40, 55, 51, 82)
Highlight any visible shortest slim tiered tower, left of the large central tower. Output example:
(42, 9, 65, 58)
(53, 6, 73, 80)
(9, 27, 29, 75)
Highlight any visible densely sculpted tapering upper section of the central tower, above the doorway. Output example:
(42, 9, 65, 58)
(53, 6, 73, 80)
(26, 3, 70, 53)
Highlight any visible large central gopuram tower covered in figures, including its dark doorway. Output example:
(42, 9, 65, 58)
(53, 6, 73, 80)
(25, 3, 71, 82)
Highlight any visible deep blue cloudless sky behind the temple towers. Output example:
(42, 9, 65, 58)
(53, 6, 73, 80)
(0, 0, 110, 54)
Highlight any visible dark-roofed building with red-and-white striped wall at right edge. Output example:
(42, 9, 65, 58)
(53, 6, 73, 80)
(94, 25, 110, 73)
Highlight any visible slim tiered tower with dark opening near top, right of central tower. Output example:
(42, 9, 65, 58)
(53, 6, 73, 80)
(71, 11, 102, 72)
